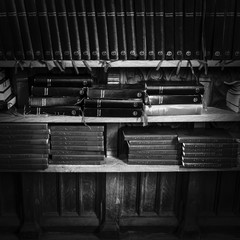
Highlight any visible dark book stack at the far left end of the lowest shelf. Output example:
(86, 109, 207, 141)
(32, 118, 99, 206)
(0, 123, 50, 170)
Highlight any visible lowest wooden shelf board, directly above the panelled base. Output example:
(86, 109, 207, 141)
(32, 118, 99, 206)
(0, 157, 240, 173)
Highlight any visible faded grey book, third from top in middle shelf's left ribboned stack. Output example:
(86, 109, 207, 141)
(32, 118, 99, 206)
(29, 97, 79, 107)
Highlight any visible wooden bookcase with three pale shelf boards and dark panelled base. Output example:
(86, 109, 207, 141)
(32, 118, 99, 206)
(0, 61, 240, 239)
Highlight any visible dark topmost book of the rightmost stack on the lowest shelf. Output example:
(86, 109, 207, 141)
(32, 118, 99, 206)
(178, 128, 236, 142)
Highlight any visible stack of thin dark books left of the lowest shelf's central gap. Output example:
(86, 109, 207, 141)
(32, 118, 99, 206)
(49, 124, 105, 165)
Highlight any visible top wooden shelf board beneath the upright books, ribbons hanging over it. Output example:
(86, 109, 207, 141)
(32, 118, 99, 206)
(0, 60, 240, 68)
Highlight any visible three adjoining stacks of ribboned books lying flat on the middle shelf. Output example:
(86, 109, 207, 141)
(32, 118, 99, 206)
(26, 75, 204, 117)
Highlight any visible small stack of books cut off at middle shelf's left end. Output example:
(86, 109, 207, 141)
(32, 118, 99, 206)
(0, 71, 16, 110)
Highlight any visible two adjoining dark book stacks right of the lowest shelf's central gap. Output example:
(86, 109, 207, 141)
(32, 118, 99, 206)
(122, 126, 239, 168)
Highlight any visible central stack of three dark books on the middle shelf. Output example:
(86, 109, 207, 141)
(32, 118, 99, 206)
(83, 84, 145, 117)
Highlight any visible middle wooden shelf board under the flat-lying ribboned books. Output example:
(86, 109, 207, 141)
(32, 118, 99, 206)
(0, 107, 240, 123)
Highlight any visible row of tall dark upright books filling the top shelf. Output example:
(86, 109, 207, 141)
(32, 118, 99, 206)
(0, 0, 240, 60)
